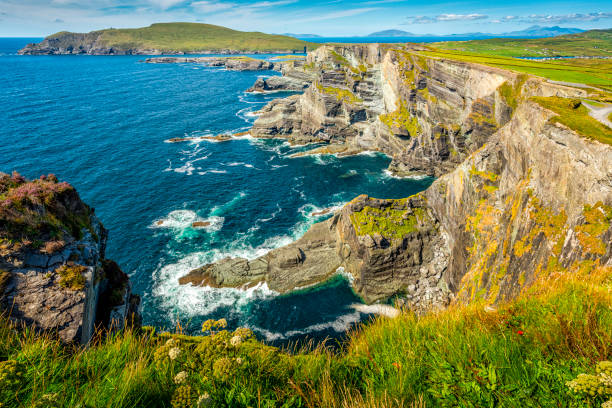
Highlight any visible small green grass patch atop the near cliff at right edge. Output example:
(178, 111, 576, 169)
(532, 96, 612, 145)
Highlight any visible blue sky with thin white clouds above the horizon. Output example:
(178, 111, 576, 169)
(0, 0, 612, 37)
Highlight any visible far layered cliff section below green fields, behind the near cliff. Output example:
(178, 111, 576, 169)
(246, 44, 592, 176)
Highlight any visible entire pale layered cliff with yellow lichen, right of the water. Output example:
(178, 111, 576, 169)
(182, 44, 612, 309)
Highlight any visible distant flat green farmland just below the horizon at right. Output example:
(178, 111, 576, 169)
(432, 29, 612, 57)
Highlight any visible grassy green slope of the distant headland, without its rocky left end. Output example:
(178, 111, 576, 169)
(51, 23, 317, 52)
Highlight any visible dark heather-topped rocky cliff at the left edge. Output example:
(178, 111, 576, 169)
(0, 173, 139, 344)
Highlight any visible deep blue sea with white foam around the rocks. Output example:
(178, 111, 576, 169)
(0, 39, 430, 341)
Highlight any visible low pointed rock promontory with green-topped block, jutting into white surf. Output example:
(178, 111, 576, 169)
(179, 196, 449, 308)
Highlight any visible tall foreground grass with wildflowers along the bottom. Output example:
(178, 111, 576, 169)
(0, 267, 612, 408)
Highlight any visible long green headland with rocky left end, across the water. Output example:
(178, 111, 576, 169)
(20, 23, 318, 55)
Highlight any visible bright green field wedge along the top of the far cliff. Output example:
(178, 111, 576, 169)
(422, 48, 612, 91)
